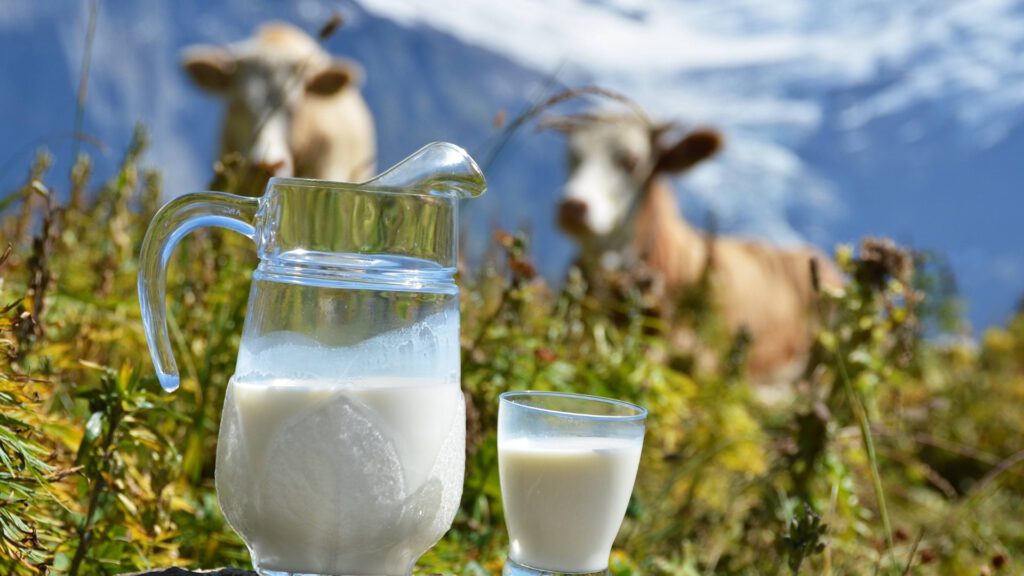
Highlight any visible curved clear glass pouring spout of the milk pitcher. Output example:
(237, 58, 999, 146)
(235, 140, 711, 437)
(364, 142, 487, 198)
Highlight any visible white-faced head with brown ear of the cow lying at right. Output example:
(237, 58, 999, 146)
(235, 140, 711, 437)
(548, 116, 722, 246)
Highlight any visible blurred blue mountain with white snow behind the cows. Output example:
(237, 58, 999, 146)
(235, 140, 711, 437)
(0, 0, 1024, 326)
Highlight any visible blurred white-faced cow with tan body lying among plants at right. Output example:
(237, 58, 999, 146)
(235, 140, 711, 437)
(549, 115, 842, 380)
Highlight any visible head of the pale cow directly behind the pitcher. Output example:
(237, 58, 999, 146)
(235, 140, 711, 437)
(182, 23, 361, 176)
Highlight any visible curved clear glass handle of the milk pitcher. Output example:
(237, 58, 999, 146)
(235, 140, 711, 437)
(138, 192, 260, 392)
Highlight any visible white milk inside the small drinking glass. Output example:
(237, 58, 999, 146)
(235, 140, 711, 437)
(498, 438, 642, 572)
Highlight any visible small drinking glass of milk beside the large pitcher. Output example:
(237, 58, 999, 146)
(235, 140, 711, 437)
(498, 390, 647, 576)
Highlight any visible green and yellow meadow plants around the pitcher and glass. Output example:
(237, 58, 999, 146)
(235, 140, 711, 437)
(0, 130, 1024, 575)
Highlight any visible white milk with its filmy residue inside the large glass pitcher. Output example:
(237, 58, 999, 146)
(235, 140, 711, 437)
(216, 309, 466, 576)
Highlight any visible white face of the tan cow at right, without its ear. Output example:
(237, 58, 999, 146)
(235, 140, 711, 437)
(562, 118, 653, 238)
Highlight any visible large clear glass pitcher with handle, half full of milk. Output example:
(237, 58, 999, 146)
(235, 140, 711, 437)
(138, 142, 486, 576)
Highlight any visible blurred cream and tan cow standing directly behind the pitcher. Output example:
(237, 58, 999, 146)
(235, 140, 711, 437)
(182, 23, 377, 182)
